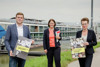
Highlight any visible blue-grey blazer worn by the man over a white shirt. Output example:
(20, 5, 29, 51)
(5, 24, 31, 52)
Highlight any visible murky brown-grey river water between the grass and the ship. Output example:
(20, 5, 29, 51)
(0, 41, 70, 67)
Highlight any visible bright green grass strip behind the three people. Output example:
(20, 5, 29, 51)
(25, 42, 100, 67)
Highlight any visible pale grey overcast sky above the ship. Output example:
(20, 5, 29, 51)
(0, 0, 100, 22)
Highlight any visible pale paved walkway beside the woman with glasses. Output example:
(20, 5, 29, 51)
(68, 48, 100, 67)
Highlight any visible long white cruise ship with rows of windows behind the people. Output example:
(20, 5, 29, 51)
(0, 17, 81, 40)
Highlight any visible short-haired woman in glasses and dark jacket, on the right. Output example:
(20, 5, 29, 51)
(76, 18, 97, 67)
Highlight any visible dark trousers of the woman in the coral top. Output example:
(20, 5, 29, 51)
(47, 47, 61, 67)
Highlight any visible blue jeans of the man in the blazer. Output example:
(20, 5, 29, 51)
(9, 56, 25, 67)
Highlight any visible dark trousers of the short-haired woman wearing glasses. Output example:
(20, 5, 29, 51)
(78, 54, 93, 67)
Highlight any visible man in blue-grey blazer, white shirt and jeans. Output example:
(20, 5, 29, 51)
(5, 12, 34, 67)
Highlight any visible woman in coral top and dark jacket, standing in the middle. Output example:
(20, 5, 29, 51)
(43, 19, 61, 67)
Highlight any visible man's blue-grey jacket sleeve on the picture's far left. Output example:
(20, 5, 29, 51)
(5, 26, 12, 52)
